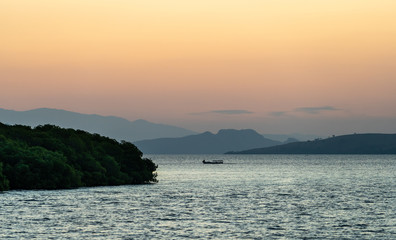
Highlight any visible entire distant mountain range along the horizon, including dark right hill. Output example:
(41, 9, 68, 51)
(0, 108, 396, 154)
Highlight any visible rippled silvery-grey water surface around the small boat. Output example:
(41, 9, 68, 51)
(0, 155, 396, 239)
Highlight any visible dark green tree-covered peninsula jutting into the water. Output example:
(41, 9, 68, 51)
(0, 123, 157, 191)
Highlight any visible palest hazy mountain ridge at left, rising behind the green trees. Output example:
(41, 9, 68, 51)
(0, 108, 196, 142)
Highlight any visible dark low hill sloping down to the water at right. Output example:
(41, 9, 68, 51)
(228, 133, 396, 154)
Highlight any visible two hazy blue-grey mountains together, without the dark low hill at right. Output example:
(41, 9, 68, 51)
(0, 108, 298, 154)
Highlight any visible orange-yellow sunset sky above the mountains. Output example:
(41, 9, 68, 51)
(0, 0, 396, 136)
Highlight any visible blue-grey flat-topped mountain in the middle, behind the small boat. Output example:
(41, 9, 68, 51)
(134, 129, 282, 154)
